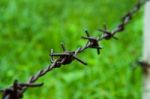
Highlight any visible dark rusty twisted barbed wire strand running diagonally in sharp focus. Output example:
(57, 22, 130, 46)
(0, 0, 150, 99)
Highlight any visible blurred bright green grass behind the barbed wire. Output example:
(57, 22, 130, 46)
(0, 0, 143, 99)
